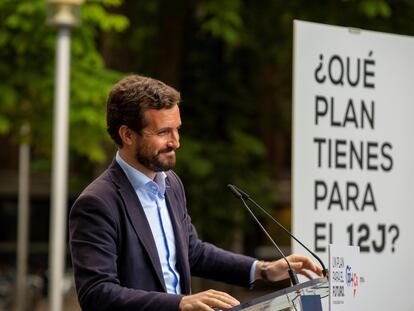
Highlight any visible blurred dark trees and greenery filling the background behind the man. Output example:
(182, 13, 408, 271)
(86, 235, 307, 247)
(0, 0, 414, 310)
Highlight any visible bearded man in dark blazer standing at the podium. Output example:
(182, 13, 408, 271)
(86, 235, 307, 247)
(70, 76, 321, 311)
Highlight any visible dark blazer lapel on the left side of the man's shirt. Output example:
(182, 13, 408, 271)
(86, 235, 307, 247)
(110, 160, 167, 291)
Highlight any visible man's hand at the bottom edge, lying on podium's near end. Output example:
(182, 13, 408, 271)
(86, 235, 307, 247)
(179, 289, 240, 311)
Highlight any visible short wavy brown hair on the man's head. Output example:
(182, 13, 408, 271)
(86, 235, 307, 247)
(106, 75, 180, 146)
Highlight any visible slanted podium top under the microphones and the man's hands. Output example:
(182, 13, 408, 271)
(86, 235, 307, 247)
(229, 278, 329, 311)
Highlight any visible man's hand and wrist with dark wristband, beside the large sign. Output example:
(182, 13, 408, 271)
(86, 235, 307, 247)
(256, 254, 322, 282)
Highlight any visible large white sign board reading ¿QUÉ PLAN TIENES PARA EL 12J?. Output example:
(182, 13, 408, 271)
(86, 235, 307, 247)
(292, 21, 414, 311)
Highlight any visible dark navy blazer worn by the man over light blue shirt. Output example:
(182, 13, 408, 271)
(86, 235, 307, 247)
(69, 161, 255, 311)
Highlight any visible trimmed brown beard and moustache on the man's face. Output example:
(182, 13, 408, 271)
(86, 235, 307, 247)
(135, 146, 176, 172)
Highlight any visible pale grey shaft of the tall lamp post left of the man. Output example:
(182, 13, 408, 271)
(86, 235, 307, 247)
(49, 27, 70, 311)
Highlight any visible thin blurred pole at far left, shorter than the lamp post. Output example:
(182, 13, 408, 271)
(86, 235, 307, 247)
(16, 123, 30, 311)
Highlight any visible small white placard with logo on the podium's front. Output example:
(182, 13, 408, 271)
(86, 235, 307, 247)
(329, 244, 362, 311)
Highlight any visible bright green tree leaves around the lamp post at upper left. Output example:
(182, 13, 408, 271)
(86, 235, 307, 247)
(0, 0, 128, 168)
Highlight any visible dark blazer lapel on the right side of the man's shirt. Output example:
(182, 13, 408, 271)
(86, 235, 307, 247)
(165, 178, 191, 294)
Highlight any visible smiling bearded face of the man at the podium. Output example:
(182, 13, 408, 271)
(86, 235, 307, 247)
(135, 105, 181, 172)
